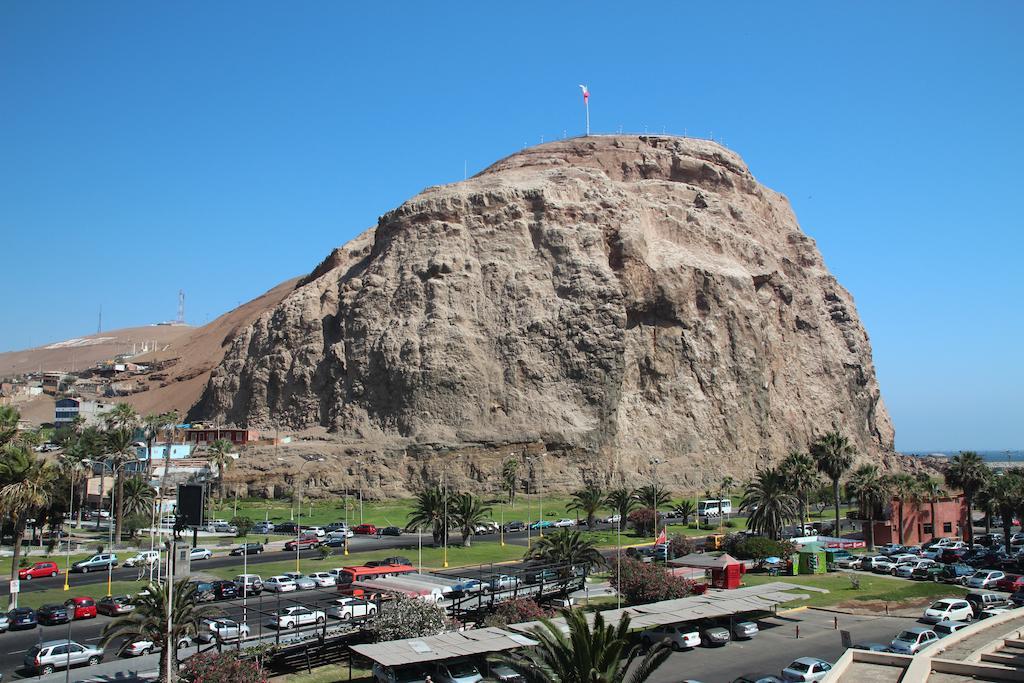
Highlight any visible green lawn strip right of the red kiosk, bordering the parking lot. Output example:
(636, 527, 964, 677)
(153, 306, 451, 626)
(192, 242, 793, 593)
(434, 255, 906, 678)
(743, 572, 967, 607)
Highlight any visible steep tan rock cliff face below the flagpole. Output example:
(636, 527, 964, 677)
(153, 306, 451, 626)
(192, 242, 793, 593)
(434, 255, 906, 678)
(196, 136, 893, 485)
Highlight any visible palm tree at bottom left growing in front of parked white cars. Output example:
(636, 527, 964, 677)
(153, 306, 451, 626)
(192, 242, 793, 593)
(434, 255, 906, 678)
(100, 581, 219, 681)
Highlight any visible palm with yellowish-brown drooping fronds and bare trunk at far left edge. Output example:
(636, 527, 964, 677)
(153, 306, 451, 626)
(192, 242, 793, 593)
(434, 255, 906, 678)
(0, 444, 56, 593)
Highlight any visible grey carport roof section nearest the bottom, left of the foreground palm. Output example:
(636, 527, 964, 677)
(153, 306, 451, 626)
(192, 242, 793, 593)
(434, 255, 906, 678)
(352, 628, 537, 667)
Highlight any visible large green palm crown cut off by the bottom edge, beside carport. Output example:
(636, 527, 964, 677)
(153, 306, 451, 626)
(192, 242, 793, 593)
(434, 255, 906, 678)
(512, 609, 671, 683)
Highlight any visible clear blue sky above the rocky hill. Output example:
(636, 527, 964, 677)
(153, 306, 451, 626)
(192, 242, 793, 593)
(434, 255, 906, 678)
(0, 1, 1024, 451)
